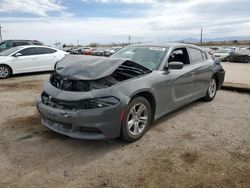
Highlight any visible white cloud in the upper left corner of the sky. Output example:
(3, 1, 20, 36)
(0, 0, 66, 16)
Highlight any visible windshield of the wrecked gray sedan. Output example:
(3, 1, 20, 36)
(111, 46, 168, 70)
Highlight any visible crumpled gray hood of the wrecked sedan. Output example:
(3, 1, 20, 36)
(56, 55, 149, 80)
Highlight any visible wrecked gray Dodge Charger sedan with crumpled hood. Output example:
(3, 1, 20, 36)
(37, 43, 225, 141)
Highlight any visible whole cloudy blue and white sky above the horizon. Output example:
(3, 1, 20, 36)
(0, 0, 250, 44)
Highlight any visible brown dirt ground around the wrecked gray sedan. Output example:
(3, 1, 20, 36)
(0, 74, 250, 188)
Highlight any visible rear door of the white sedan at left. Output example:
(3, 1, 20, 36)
(36, 47, 58, 71)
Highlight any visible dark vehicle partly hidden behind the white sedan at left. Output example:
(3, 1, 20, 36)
(0, 40, 43, 52)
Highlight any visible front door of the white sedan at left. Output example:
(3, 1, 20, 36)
(13, 47, 38, 73)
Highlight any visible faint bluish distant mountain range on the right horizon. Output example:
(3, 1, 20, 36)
(177, 36, 250, 43)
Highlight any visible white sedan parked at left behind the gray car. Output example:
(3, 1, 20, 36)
(0, 45, 68, 78)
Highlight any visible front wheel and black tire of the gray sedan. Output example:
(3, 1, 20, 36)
(121, 97, 152, 142)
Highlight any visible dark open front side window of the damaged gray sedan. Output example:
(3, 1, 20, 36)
(168, 48, 190, 65)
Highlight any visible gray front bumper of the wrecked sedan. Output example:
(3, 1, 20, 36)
(36, 96, 123, 140)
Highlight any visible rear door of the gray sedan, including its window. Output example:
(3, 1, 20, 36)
(188, 47, 213, 99)
